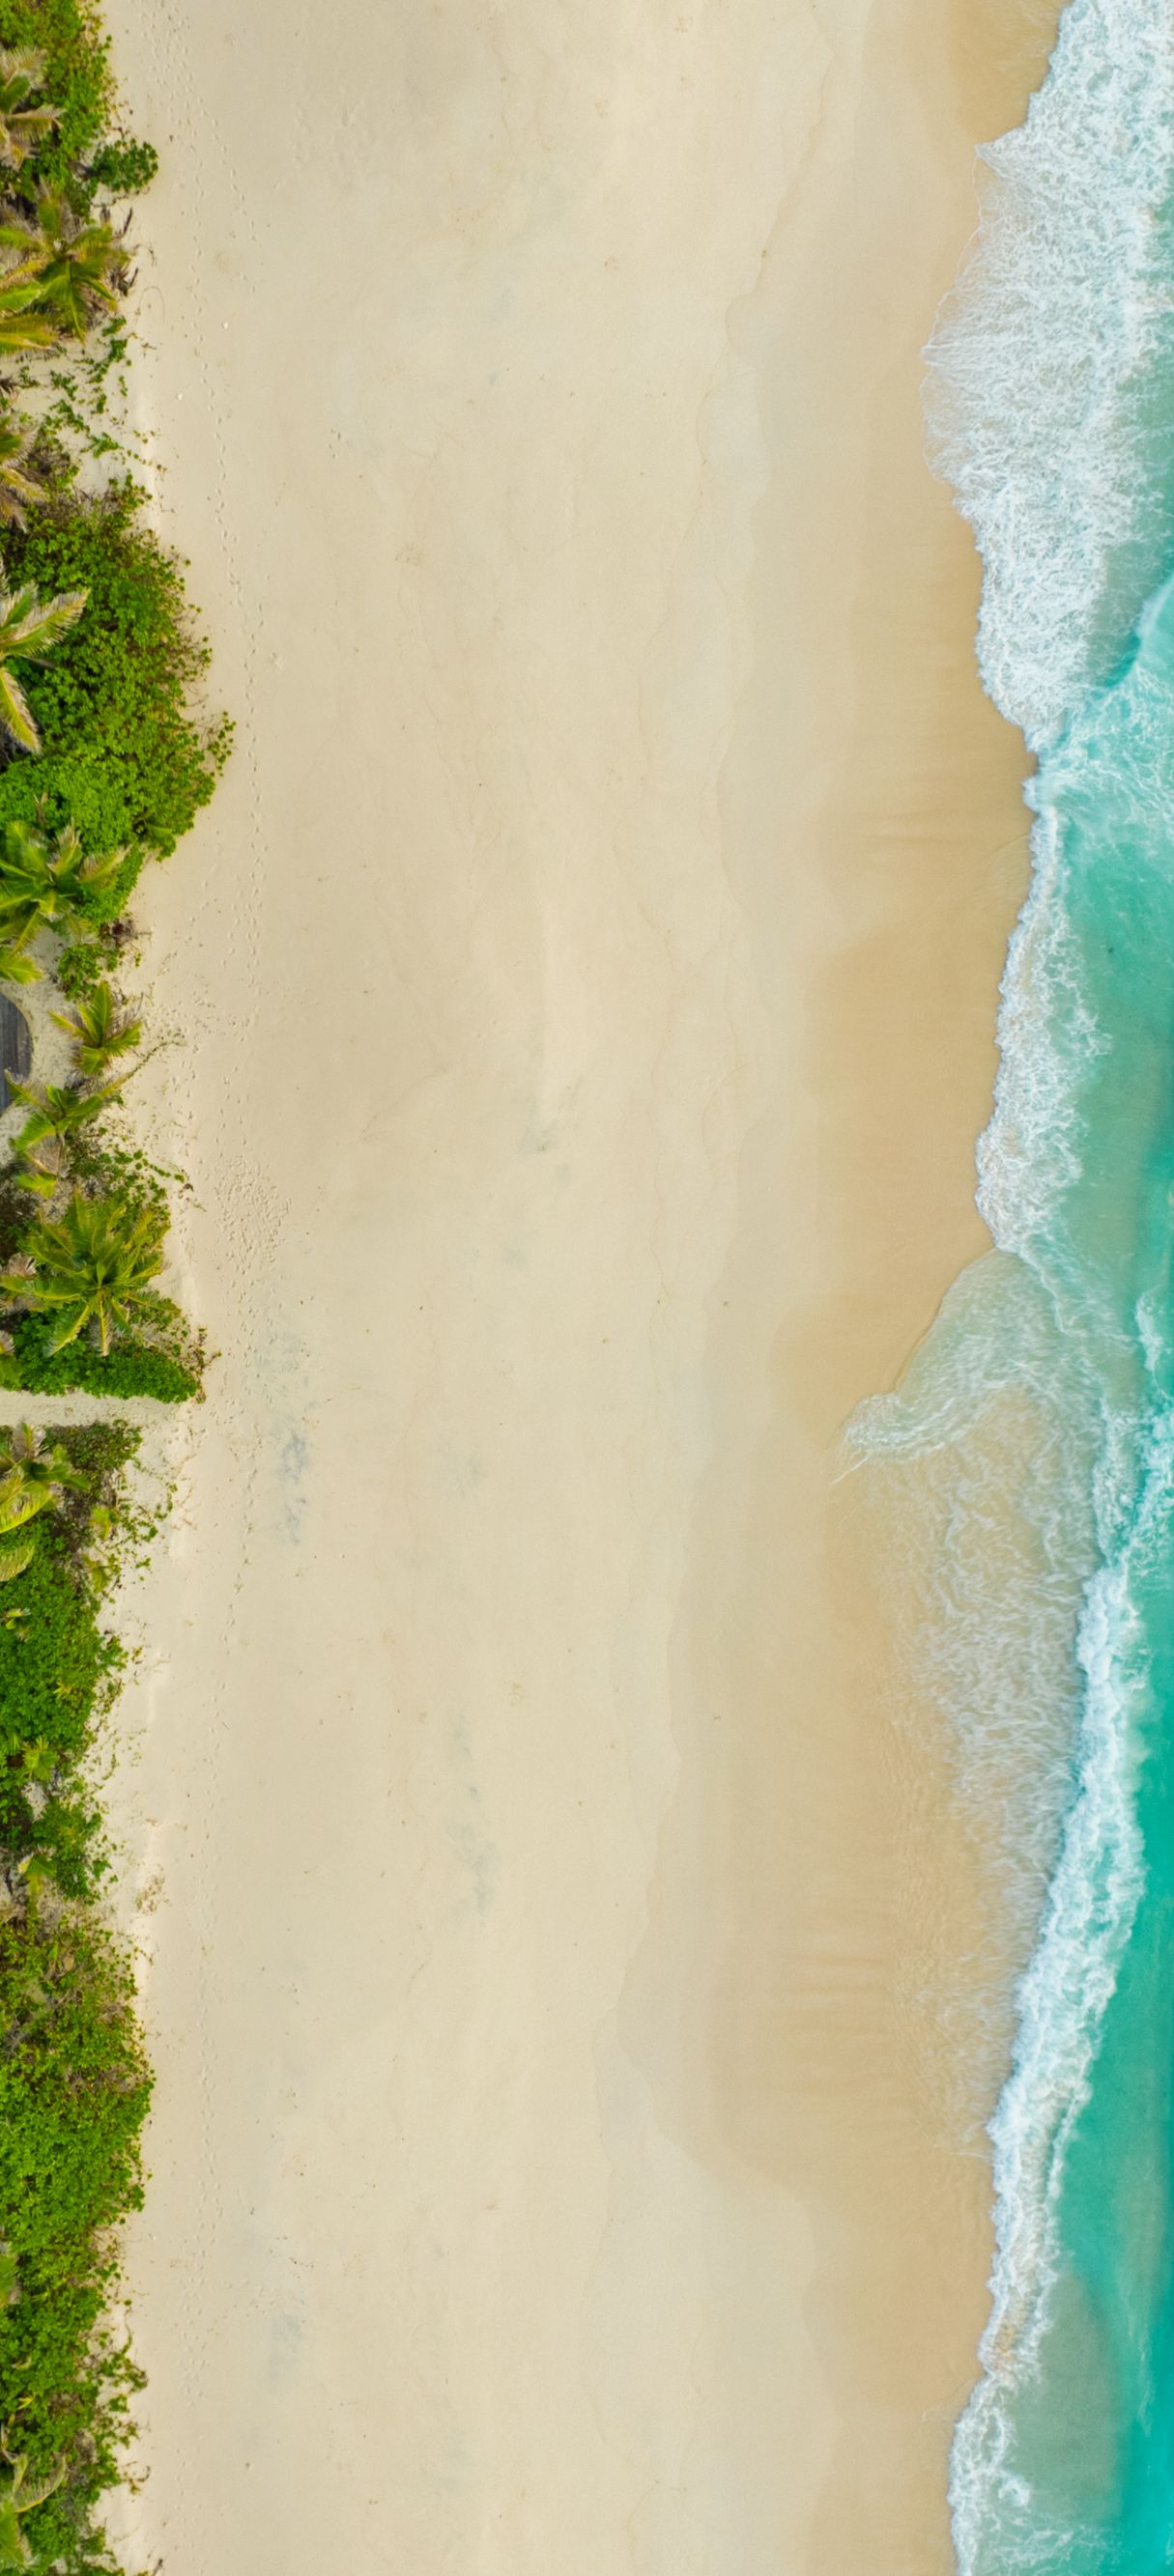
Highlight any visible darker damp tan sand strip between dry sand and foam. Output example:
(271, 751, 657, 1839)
(623, 8, 1058, 2576)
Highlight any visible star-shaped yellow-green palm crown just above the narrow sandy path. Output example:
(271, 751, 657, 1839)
(0, 1190, 167, 1352)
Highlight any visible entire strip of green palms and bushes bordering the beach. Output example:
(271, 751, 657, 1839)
(0, 0, 232, 2576)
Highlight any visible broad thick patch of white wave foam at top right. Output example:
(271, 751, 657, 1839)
(927, 0, 1174, 750)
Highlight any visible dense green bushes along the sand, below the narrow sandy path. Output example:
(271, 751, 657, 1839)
(0, 1422, 152, 2576)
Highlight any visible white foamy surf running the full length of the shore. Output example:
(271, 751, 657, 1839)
(849, 0, 1174, 2576)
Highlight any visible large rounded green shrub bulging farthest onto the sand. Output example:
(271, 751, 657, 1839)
(0, 479, 232, 881)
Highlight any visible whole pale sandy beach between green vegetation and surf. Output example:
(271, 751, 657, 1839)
(86, 0, 1045, 2576)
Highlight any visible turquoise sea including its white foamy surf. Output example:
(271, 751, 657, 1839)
(849, 0, 1174, 2576)
